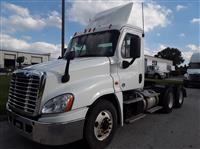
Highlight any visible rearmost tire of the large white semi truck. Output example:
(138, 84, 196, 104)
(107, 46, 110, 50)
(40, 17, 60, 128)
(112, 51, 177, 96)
(175, 87, 184, 108)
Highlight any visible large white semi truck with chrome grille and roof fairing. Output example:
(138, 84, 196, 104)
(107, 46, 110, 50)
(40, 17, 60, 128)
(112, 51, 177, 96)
(7, 3, 186, 149)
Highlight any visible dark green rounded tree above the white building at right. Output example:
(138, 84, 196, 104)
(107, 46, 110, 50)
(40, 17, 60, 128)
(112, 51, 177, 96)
(155, 47, 184, 68)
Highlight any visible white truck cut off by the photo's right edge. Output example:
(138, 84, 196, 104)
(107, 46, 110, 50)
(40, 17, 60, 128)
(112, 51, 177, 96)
(183, 52, 200, 87)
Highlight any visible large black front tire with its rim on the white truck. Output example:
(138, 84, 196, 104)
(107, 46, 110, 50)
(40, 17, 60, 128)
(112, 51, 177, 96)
(84, 100, 117, 149)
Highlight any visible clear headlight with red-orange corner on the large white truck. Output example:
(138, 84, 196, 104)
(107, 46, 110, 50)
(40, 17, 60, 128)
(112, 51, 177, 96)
(42, 94, 74, 114)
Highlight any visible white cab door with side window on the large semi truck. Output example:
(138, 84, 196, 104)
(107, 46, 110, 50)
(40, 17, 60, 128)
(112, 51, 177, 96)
(118, 31, 144, 91)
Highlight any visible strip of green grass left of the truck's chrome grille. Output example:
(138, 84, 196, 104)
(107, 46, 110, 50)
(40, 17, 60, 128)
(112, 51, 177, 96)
(0, 75, 10, 115)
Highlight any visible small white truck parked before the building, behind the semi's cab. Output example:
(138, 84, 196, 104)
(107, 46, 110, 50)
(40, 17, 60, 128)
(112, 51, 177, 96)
(145, 65, 166, 79)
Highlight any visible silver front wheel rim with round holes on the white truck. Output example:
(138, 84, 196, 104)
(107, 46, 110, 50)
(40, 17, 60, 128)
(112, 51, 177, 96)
(94, 110, 113, 141)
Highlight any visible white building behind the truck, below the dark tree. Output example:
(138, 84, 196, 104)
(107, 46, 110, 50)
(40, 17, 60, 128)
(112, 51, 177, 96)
(144, 55, 175, 74)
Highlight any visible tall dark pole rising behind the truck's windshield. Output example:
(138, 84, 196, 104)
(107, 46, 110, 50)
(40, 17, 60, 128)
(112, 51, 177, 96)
(61, 0, 65, 57)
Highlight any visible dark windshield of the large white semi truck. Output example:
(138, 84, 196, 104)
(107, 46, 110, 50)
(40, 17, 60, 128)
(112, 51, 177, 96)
(64, 30, 119, 58)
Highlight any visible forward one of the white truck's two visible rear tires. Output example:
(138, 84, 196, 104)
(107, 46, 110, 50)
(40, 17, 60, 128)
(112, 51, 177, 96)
(162, 87, 174, 113)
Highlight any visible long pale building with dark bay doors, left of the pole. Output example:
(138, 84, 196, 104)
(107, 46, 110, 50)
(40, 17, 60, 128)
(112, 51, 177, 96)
(0, 50, 50, 69)
